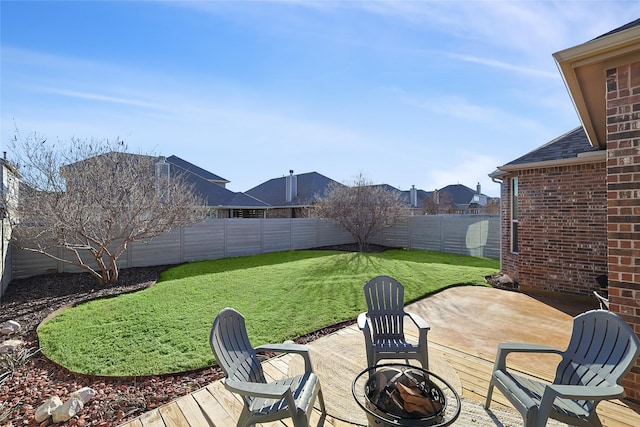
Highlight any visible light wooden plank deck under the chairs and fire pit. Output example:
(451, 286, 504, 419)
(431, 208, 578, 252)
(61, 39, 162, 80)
(120, 332, 640, 427)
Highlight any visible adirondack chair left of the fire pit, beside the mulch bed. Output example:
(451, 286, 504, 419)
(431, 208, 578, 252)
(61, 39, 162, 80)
(209, 308, 326, 427)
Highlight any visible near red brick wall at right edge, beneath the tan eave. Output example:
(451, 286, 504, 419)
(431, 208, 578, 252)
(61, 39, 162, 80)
(607, 62, 640, 401)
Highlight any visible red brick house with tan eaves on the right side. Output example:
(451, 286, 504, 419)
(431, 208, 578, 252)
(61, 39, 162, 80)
(491, 19, 640, 400)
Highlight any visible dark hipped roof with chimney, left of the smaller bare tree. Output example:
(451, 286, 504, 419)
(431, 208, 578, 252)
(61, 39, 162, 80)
(245, 172, 344, 207)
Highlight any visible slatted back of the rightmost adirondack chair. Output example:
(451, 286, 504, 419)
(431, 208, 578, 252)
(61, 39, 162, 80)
(554, 310, 640, 386)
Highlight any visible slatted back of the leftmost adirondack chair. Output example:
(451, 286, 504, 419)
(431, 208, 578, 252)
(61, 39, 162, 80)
(209, 308, 267, 383)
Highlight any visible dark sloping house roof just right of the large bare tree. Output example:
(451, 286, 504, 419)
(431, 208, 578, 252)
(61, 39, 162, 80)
(167, 156, 269, 208)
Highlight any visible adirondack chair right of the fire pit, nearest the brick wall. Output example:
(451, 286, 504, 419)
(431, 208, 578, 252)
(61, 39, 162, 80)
(485, 310, 640, 427)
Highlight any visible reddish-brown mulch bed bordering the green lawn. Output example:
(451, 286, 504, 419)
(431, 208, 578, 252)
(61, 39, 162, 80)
(0, 245, 376, 427)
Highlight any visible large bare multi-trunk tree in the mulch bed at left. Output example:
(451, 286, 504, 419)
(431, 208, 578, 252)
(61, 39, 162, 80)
(11, 133, 203, 285)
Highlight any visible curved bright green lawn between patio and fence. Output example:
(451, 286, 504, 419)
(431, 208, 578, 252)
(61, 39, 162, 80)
(38, 249, 499, 376)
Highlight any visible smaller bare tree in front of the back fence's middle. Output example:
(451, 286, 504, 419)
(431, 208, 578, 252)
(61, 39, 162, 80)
(314, 174, 406, 252)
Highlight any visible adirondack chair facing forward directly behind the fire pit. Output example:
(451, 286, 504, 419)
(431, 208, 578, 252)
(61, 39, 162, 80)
(358, 276, 429, 369)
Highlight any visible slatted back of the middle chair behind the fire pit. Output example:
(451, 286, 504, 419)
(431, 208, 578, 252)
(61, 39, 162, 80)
(363, 276, 404, 340)
